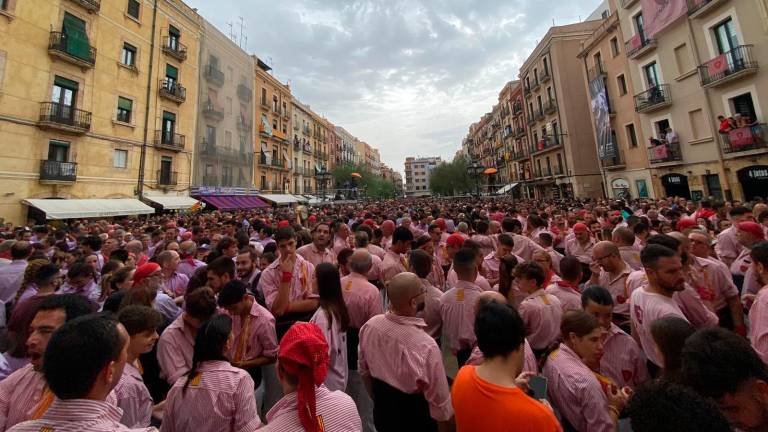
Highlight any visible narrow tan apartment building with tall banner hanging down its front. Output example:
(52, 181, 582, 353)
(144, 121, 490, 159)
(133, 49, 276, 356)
(578, 2, 656, 198)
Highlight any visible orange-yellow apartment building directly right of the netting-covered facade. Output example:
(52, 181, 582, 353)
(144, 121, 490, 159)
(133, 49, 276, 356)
(253, 56, 294, 194)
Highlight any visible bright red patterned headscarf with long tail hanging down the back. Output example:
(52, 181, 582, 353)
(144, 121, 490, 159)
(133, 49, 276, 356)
(278, 322, 330, 432)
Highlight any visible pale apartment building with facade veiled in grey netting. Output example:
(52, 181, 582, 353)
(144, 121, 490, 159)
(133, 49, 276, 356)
(193, 20, 255, 189)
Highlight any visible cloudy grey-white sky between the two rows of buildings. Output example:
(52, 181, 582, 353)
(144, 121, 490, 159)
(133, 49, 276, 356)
(185, 0, 600, 176)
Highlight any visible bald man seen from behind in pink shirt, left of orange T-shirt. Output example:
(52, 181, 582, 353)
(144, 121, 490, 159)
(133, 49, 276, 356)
(358, 272, 453, 431)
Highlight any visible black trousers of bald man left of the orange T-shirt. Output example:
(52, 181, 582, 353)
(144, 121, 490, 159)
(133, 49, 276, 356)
(372, 378, 437, 432)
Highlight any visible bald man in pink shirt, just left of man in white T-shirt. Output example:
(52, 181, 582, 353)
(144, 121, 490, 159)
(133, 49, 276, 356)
(590, 241, 632, 331)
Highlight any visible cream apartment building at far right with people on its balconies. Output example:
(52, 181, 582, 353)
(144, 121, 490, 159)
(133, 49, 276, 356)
(614, 0, 768, 200)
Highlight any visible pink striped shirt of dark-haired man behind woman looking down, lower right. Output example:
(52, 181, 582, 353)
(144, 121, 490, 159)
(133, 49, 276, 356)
(600, 323, 648, 389)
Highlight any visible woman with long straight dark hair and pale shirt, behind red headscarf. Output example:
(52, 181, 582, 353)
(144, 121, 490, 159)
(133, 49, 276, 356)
(309, 263, 349, 391)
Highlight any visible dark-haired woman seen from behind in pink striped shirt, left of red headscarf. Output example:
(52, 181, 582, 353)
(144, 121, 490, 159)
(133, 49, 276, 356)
(163, 315, 261, 432)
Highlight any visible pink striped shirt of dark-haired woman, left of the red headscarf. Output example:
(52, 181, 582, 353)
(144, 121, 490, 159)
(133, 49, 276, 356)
(163, 361, 261, 432)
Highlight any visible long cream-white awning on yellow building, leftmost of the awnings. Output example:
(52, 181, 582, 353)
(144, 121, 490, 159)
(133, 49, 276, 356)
(22, 198, 155, 219)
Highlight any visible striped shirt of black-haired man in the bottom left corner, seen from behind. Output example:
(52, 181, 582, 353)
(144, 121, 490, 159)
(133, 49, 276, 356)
(9, 399, 156, 432)
